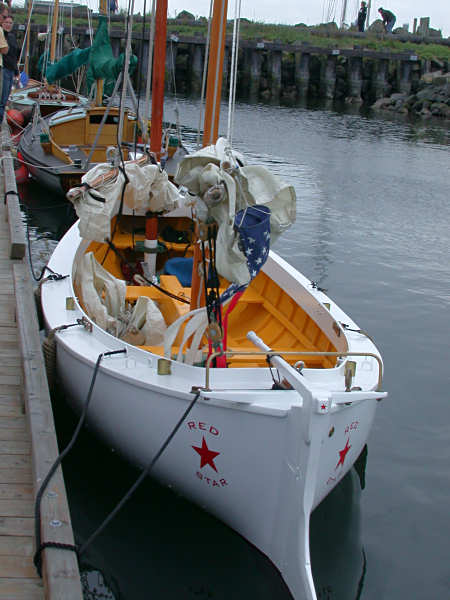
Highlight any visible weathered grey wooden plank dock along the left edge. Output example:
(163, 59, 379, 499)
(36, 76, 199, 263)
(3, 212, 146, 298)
(0, 130, 83, 600)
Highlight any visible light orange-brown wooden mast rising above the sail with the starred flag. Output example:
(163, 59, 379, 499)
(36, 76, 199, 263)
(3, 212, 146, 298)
(203, 0, 228, 146)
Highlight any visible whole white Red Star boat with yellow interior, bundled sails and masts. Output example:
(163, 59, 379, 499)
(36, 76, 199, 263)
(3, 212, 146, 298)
(41, 1, 386, 600)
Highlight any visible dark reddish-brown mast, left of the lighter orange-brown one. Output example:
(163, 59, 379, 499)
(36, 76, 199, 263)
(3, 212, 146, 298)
(150, 0, 167, 154)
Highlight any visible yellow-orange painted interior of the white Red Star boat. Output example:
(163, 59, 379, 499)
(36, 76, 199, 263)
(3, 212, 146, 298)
(83, 213, 336, 368)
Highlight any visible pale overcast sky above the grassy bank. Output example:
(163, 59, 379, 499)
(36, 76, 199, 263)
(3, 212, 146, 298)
(117, 0, 450, 37)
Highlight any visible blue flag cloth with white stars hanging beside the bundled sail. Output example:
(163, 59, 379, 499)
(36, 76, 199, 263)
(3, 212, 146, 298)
(220, 204, 270, 302)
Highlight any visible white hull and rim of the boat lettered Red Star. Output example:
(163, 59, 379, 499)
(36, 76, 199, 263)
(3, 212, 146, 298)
(42, 225, 385, 598)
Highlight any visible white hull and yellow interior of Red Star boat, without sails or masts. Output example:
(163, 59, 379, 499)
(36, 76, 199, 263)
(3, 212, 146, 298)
(42, 142, 386, 598)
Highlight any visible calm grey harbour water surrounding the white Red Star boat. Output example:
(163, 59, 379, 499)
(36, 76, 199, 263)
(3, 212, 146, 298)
(22, 100, 450, 600)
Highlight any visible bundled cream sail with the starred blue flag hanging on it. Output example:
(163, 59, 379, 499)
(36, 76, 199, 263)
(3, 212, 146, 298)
(175, 138, 296, 290)
